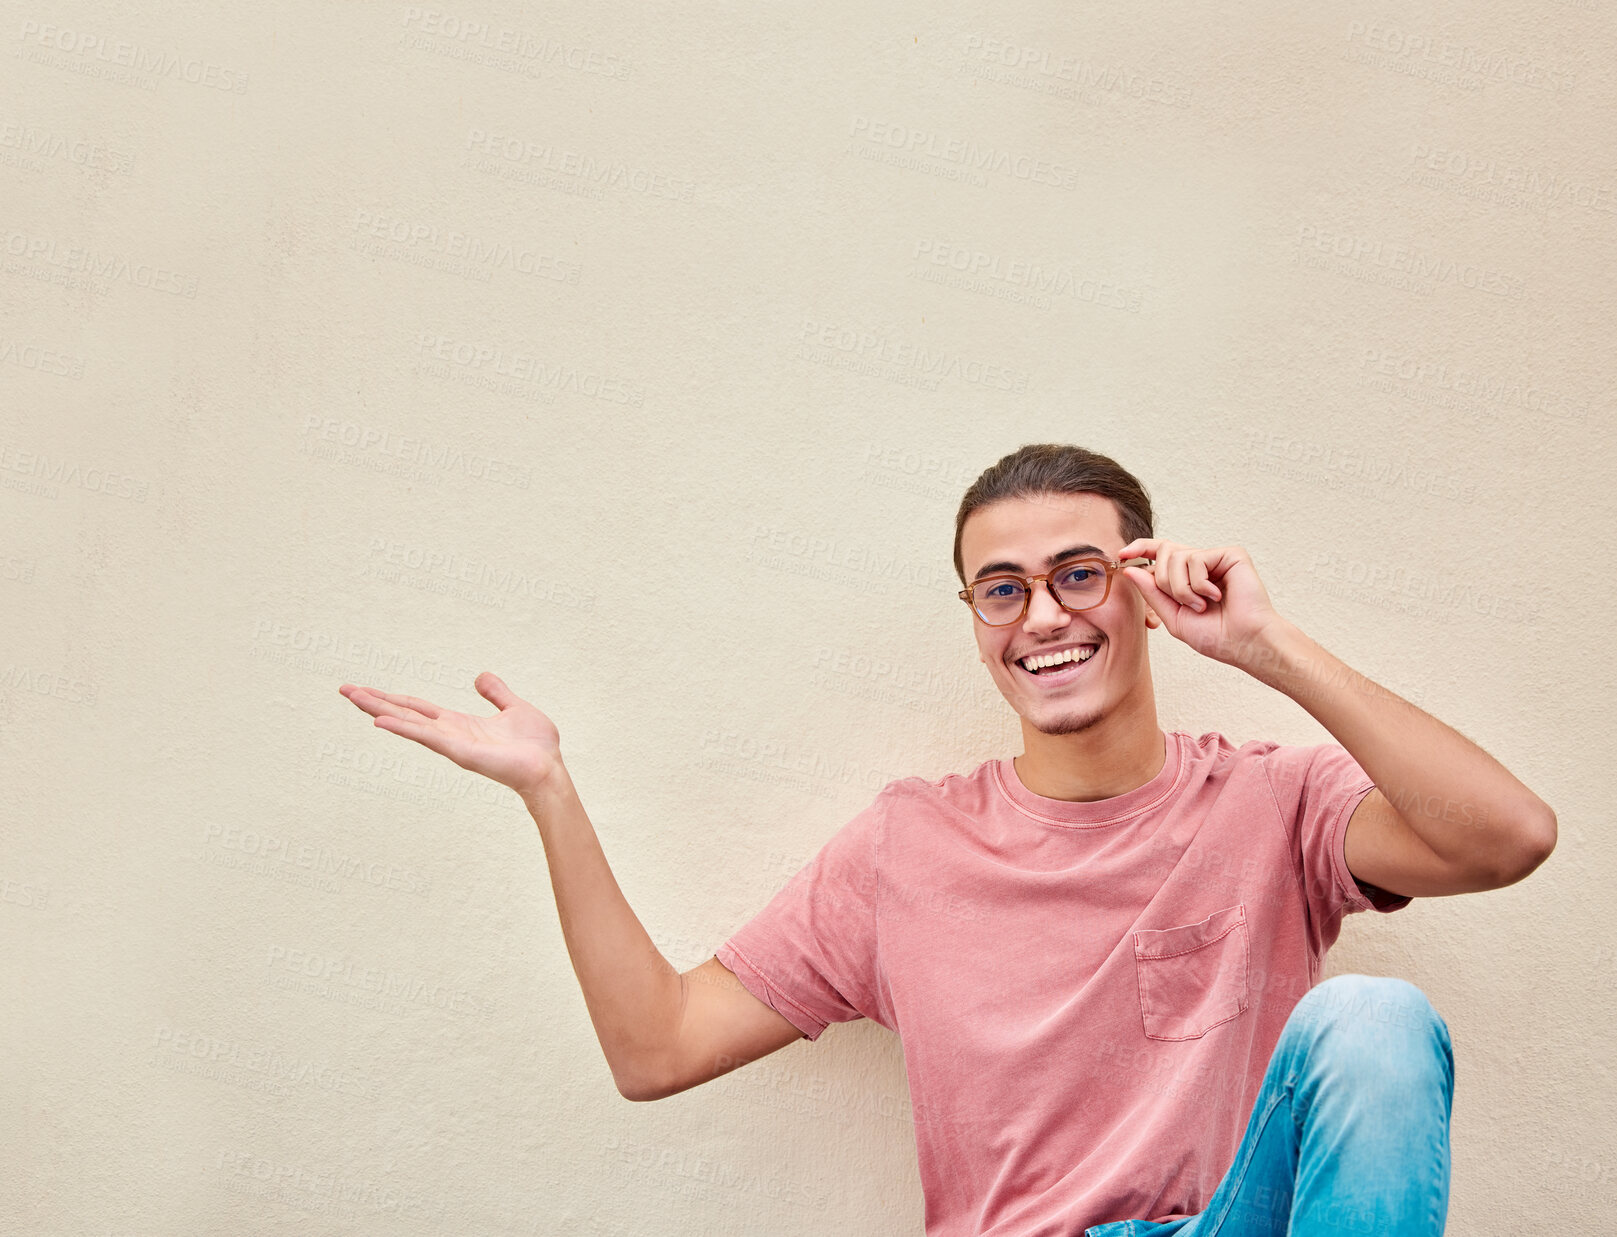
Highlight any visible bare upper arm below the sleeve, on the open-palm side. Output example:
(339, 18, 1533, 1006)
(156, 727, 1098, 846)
(632, 957, 802, 1100)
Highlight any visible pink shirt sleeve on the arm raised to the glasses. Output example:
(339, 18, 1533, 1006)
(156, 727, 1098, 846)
(1263, 744, 1410, 944)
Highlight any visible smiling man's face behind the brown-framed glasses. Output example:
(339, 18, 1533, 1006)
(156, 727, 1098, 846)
(960, 493, 1148, 734)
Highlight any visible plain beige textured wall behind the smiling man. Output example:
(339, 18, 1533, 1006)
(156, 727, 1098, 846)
(0, 2, 1617, 1234)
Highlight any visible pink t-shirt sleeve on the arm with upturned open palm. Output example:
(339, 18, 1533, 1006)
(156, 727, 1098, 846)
(715, 794, 884, 1040)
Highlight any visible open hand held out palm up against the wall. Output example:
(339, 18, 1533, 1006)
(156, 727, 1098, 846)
(336, 669, 561, 797)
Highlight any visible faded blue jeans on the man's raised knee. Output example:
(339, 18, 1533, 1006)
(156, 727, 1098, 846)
(1083, 975, 1454, 1237)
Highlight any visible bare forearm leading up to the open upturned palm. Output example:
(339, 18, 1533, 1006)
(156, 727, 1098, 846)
(522, 766, 684, 1095)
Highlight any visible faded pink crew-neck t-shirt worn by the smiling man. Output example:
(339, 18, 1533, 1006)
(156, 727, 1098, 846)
(716, 731, 1410, 1237)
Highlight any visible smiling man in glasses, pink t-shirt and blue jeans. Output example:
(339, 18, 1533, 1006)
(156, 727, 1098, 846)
(341, 445, 1556, 1237)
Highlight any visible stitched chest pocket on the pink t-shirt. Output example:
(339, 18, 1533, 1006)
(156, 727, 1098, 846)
(1134, 902, 1247, 1040)
